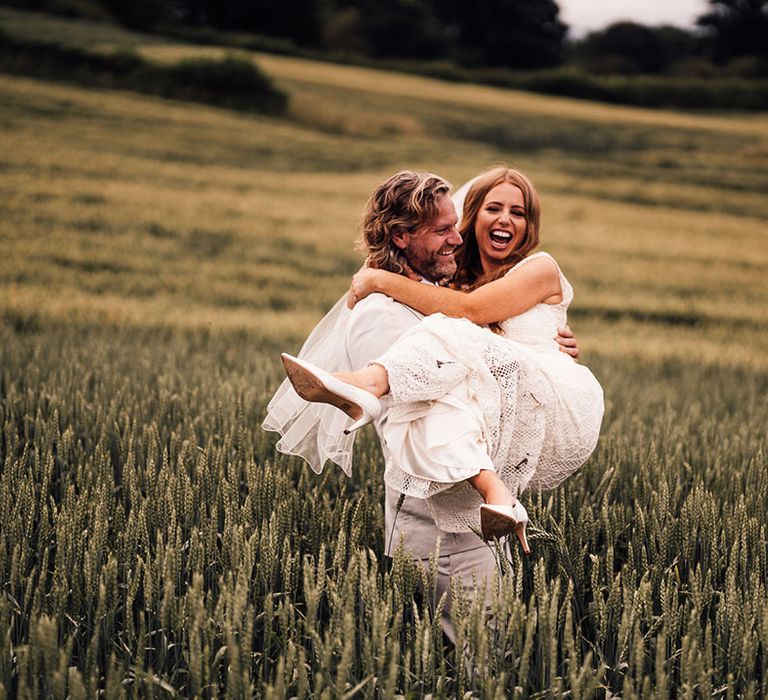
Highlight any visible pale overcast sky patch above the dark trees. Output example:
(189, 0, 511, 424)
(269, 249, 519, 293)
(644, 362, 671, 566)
(557, 0, 709, 37)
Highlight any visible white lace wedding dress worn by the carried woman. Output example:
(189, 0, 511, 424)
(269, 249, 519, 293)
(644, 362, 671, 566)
(375, 252, 603, 532)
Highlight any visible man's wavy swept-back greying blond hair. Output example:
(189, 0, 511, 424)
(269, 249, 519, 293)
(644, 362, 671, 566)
(358, 170, 451, 274)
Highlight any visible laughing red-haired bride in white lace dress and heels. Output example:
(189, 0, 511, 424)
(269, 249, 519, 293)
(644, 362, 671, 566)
(284, 168, 603, 551)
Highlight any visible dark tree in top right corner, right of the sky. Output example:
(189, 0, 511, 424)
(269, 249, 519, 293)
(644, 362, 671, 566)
(697, 0, 768, 62)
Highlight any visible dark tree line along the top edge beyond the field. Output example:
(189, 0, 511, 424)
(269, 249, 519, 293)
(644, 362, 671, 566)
(0, 0, 768, 76)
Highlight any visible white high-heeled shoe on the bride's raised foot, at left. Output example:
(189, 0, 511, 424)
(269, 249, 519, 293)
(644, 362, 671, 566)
(280, 352, 381, 435)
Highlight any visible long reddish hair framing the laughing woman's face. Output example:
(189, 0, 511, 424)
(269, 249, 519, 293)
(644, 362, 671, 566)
(454, 166, 541, 289)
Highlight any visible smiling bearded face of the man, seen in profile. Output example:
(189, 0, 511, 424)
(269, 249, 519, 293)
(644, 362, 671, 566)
(395, 194, 461, 282)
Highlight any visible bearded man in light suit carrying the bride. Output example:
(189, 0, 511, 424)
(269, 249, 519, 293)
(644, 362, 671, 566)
(344, 171, 578, 641)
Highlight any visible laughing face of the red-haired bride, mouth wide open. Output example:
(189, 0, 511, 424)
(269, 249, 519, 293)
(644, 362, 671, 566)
(475, 182, 528, 272)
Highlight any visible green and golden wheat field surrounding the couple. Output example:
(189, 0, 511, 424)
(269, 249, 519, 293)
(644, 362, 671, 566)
(0, 8, 768, 698)
